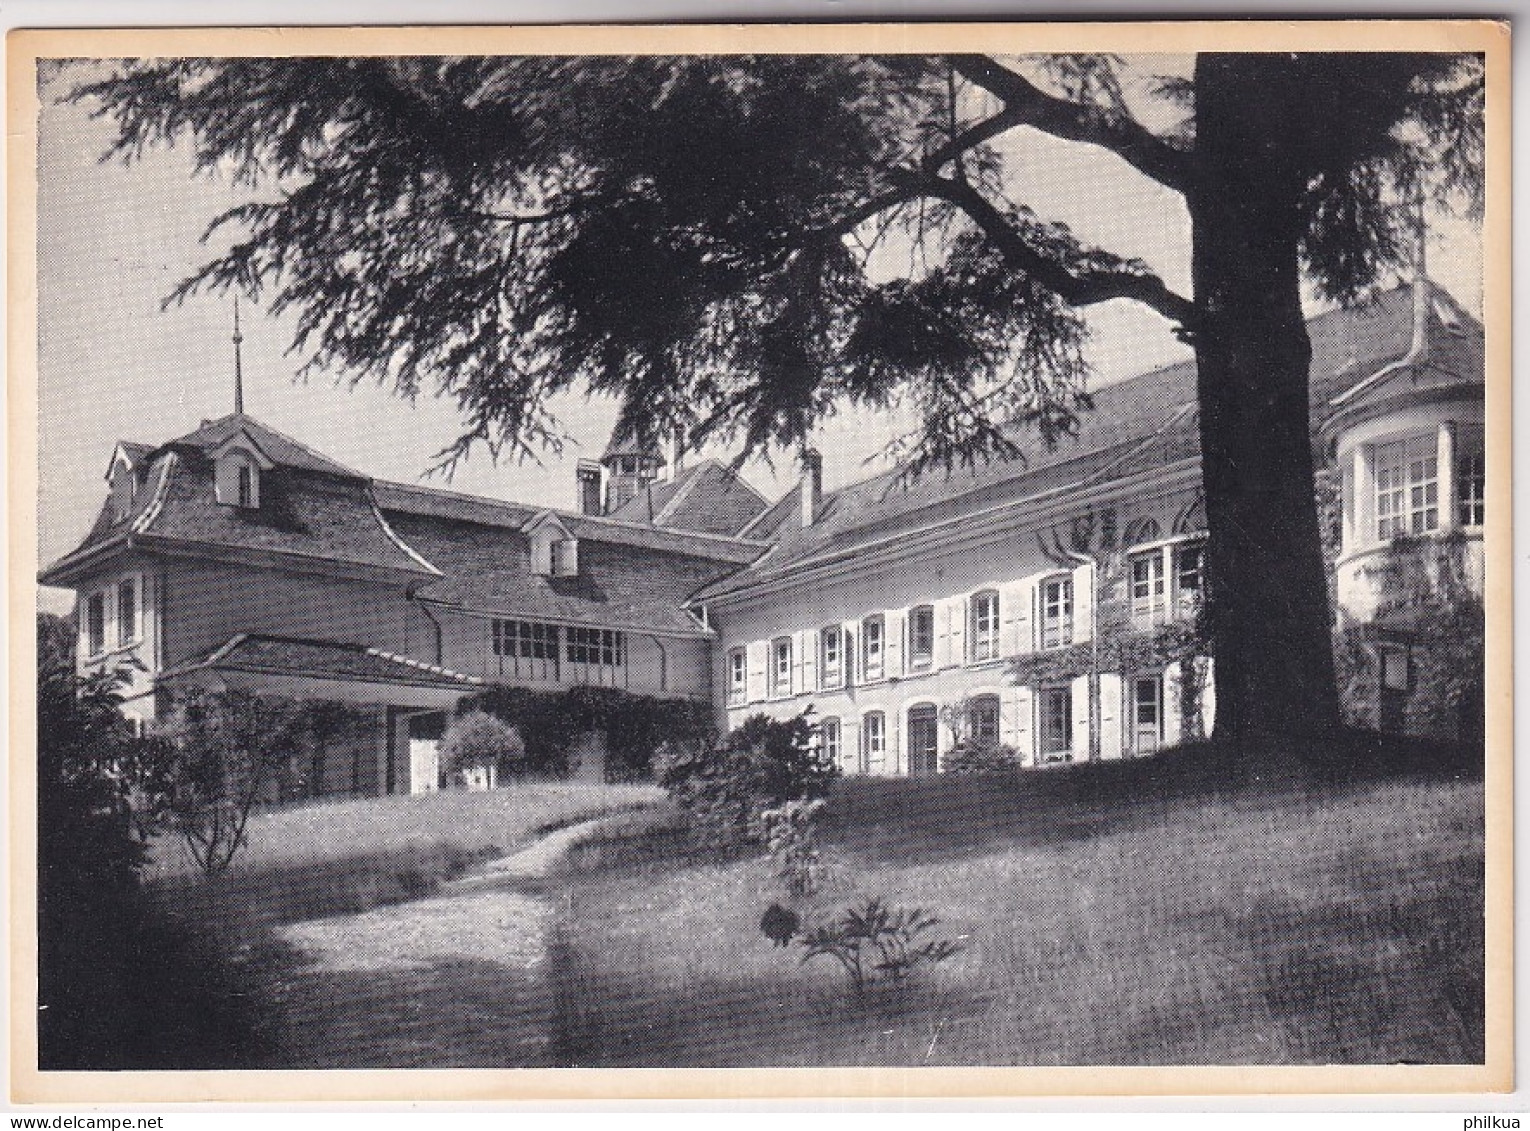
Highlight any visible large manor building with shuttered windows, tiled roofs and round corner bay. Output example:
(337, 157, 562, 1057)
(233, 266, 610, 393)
(41, 280, 1487, 793)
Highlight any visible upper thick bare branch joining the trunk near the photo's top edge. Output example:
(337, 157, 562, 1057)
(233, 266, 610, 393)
(948, 55, 1190, 193)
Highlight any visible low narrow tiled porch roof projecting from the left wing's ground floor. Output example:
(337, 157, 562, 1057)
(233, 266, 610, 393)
(162, 634, 483, 689)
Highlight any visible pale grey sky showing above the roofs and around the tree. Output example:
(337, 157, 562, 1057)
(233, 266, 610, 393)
(38, 56, 1481, 611)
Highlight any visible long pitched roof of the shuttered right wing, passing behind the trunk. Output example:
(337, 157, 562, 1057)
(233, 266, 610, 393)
(696, 286, 1481, 598)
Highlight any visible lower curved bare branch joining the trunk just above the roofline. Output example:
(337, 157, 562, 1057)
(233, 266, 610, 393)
(909, 174, 1195, 331)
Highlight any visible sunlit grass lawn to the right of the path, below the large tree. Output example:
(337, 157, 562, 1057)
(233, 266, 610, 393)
(551, 753, 1483, 1067)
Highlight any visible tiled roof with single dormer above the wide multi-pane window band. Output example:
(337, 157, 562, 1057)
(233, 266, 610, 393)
(386, 510, 736, 637)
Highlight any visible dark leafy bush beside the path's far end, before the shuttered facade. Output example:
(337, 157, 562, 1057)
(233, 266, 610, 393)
(658, 715, 838, 849)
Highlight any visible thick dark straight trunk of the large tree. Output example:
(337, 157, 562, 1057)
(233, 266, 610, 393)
(1187, 55, 1339, 758)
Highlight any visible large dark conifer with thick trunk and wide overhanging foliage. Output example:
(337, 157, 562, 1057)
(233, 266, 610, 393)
(77, 54, 1483, 756)
